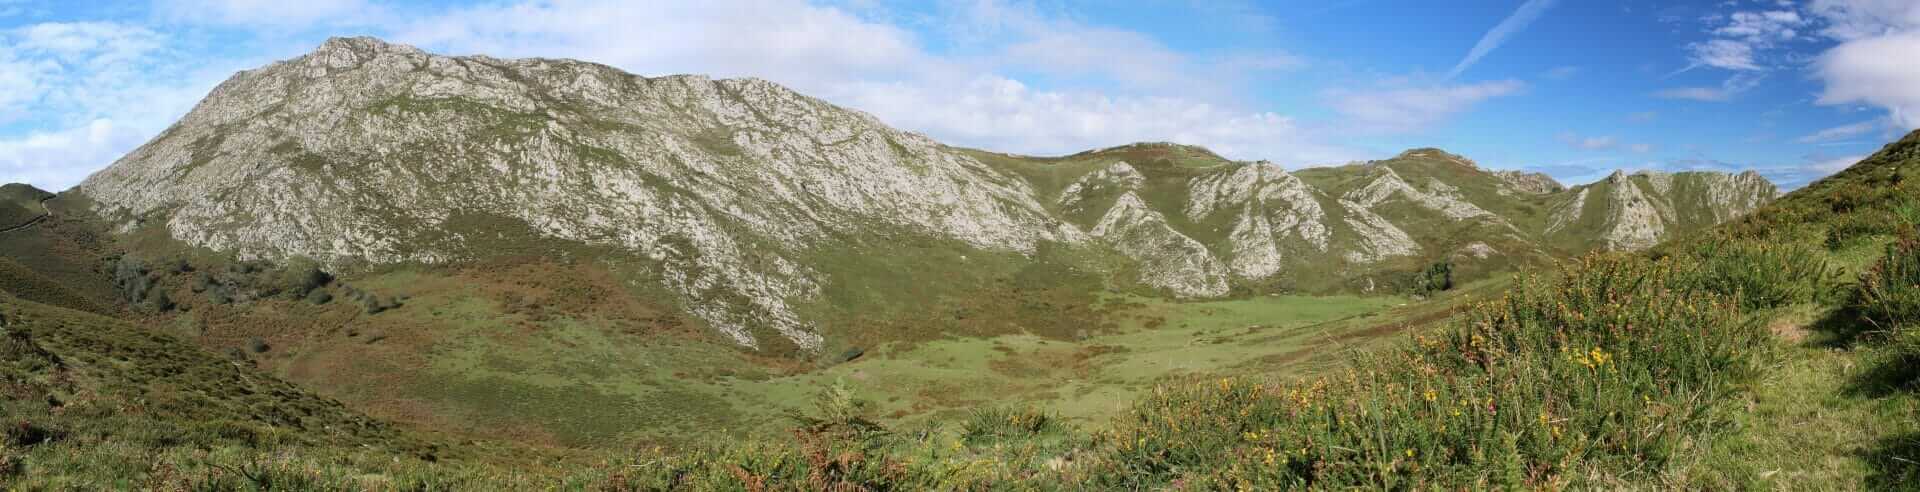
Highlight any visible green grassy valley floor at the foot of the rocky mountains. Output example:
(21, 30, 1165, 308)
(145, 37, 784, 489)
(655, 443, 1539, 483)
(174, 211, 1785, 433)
(251, 271, 1415, 446)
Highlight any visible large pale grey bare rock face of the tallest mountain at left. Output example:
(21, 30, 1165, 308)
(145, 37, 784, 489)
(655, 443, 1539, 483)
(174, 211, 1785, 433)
(81, 38, 1081, 348)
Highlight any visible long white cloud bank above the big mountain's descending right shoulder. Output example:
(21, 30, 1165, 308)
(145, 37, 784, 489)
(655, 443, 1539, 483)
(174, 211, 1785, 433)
(385, 0, 1359, 161)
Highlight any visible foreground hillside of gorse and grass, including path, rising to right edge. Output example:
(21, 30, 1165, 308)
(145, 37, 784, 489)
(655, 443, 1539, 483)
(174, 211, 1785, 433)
(8, 133, 1920, 490)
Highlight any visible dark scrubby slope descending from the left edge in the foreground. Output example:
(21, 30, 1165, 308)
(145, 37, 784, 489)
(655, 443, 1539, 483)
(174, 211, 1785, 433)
(0, 292, 436, 488)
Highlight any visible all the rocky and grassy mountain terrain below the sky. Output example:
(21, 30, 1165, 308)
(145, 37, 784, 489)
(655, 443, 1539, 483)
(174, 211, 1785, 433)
(0, 31, 1920, 490)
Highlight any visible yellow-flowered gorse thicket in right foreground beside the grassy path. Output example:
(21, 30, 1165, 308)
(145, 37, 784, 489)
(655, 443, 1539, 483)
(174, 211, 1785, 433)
(1091, 256, 1776, 488)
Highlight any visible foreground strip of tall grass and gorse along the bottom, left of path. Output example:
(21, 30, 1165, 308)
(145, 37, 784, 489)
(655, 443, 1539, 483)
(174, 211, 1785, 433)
(0, 244, 1827, 490)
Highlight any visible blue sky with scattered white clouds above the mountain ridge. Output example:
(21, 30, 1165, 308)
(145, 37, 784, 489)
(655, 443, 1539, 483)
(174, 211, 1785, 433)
(0, 0, 1920, 188)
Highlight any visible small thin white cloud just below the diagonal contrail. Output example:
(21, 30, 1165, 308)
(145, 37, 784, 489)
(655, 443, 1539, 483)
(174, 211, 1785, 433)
(1327, 81, 1526, 133)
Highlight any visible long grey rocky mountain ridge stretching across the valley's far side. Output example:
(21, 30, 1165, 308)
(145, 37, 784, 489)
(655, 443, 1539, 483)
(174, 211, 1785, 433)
(74, 38, 1776, 352)
